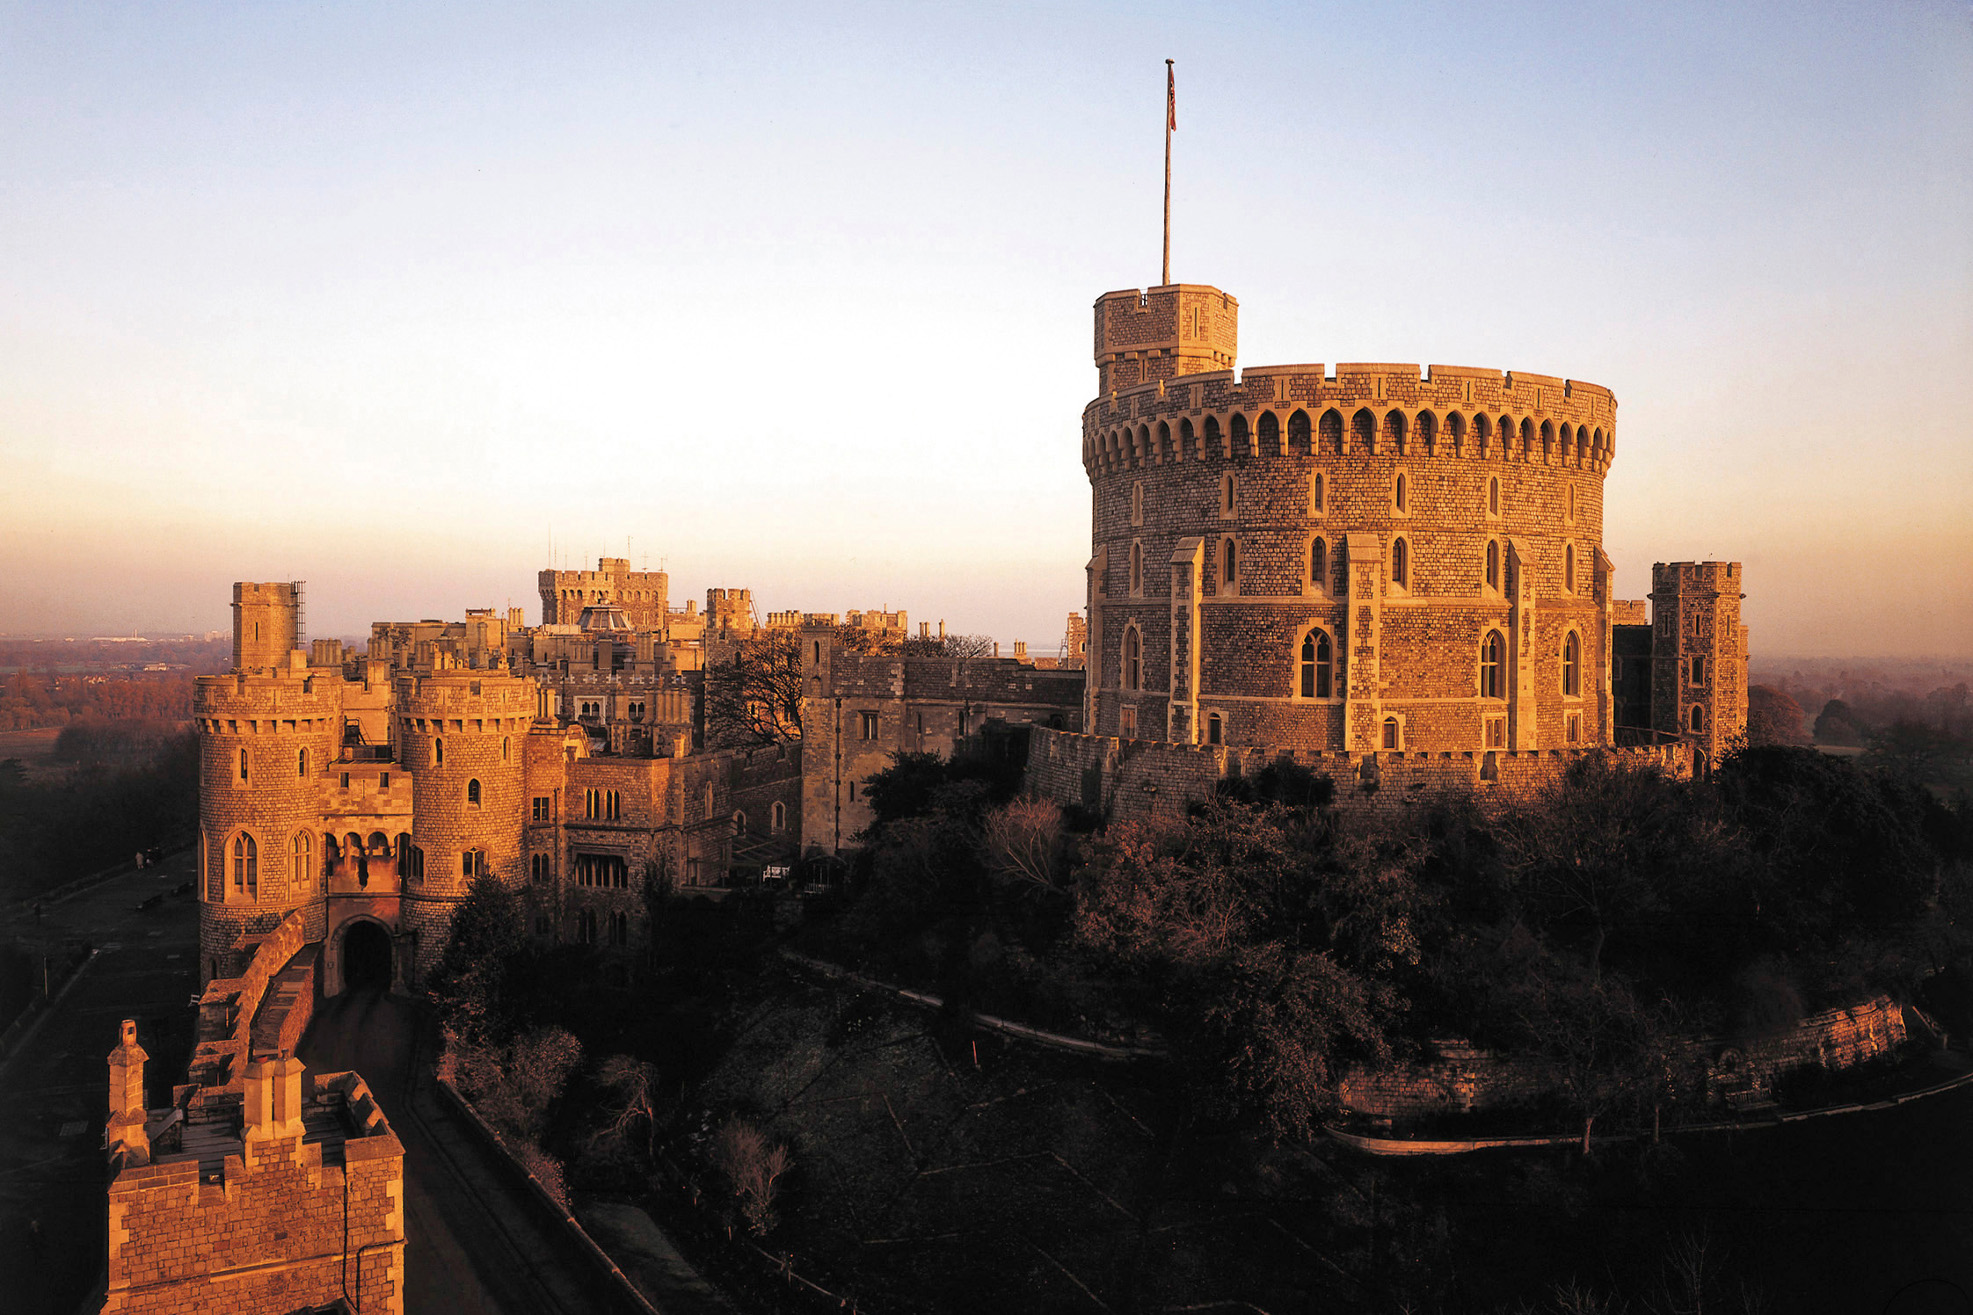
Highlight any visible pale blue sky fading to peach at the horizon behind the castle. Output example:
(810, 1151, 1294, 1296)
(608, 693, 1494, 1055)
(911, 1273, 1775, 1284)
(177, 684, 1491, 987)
(0, 0, 1973, 654)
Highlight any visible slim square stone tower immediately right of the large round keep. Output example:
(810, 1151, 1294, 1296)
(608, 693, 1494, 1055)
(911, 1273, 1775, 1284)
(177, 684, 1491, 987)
(1651, 561, 1746, 762)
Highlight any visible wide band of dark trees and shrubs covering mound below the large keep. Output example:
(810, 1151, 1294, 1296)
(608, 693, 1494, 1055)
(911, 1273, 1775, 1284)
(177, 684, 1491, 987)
(820, 730, 1973, 1137)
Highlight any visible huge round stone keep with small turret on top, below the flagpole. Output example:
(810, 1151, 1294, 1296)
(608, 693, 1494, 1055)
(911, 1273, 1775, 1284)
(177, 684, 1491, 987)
(1083, 284, 1616, 754)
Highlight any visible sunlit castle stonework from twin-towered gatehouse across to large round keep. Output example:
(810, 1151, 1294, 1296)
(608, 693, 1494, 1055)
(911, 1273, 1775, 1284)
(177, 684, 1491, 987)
(197, 284, 1746, 993)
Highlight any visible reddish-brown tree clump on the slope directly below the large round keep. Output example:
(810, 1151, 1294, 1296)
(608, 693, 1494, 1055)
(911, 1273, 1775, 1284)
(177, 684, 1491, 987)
(1075, 800, 1421, 1137)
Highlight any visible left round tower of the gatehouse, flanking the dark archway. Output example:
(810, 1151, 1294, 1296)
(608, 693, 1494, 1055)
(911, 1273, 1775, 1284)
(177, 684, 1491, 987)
(193, 654, 343, 983)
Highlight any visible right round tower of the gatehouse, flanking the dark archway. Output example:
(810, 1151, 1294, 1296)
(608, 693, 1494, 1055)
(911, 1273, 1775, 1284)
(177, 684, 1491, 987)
(397, 667, 537, 981)
